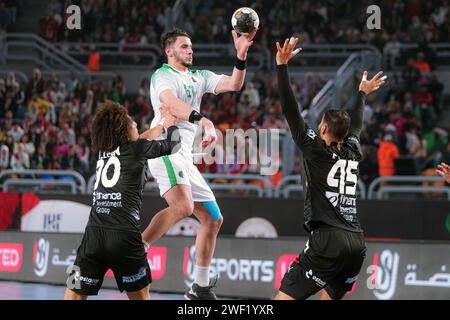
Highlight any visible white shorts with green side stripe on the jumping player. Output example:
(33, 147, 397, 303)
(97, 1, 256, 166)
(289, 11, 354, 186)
(148, 152, 216, 202)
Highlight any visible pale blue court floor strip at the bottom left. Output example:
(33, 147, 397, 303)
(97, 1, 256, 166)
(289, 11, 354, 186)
(0, 281, 184, 300)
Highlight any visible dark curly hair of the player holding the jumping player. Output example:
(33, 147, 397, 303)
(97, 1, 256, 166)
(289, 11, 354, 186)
(91, 100, 131, 152)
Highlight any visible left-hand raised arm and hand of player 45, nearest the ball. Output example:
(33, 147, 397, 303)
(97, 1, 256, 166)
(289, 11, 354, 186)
(276, 38, 305, 144)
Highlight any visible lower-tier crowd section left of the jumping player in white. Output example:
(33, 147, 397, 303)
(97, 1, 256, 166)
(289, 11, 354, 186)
(0, 69, 150, 177)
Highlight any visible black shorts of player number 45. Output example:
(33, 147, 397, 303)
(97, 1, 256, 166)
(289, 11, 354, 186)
(280, 226, 366, 300)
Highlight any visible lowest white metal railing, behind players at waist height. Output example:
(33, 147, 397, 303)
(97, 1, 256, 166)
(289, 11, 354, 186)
(0, 170, 450, 200)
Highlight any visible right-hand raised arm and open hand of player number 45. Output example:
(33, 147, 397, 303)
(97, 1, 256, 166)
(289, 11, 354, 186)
(349, 71, 386, 137)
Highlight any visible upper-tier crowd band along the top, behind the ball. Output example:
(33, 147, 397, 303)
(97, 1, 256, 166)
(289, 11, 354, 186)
(40, 0, 450, 65)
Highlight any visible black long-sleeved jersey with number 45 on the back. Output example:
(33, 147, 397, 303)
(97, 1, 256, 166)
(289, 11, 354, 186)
(278, 65, 365, 232)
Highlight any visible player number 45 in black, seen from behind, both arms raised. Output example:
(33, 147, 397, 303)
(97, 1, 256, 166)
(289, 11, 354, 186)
(275, 38, 384, 300)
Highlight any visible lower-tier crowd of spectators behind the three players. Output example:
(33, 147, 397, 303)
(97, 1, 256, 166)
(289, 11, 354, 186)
(0, 49, 450, 189)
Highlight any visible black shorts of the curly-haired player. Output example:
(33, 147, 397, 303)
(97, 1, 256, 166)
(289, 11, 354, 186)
(67, 227, 152, 295)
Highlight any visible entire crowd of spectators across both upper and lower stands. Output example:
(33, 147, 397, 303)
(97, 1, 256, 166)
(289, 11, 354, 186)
(0, 0, 450, 192)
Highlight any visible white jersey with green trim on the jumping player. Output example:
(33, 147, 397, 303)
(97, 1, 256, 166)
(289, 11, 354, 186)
(150, 64, 223, 154)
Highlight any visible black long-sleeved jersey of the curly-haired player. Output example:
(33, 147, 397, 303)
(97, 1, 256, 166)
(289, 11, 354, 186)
(87, 127, 180, 232)
